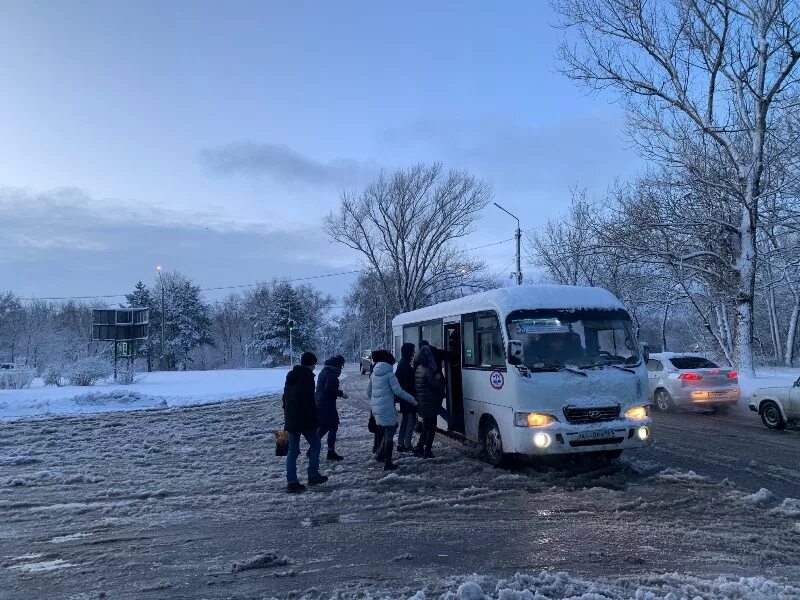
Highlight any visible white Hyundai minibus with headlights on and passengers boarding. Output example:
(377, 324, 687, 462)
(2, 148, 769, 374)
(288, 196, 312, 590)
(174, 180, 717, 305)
(392, 285, 653, 465)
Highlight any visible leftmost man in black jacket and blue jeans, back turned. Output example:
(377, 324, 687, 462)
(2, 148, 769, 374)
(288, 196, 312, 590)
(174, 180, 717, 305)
(283, 352, 328, 493)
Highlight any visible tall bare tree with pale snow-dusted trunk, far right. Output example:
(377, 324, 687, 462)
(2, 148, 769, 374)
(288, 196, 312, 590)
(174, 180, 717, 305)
(555, 0, 800, 372)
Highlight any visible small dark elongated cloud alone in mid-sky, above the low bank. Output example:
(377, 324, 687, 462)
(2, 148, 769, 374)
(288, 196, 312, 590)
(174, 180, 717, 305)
(200, 140, 378, 186)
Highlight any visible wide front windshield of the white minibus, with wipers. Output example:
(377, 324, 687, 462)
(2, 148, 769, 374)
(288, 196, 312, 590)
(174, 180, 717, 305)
(506, 310, 641, 371)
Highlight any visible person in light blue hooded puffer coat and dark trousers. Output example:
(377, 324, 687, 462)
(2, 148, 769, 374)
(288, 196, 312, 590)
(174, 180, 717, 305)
(369, 350, 417, 471)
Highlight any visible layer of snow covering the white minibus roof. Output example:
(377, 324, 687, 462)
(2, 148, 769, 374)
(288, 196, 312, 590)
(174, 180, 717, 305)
(392, 285, 625, 326)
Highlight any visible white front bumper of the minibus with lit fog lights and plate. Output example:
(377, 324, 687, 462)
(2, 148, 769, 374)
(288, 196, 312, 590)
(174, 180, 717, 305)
(514, 419, 653, 456)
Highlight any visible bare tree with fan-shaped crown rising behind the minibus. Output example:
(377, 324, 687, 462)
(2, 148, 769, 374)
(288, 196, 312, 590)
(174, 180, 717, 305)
(324, 163, 492, 312)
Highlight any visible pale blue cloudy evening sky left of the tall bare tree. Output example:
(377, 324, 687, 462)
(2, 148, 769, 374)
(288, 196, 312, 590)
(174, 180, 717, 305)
(0, 0, 638, 299)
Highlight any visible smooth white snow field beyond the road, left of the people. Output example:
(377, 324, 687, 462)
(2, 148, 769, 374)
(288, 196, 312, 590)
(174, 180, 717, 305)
(0, 369, 288, 420)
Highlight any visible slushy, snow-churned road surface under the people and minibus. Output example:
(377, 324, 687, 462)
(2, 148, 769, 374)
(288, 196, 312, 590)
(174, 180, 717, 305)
(0, 368, 800, 600)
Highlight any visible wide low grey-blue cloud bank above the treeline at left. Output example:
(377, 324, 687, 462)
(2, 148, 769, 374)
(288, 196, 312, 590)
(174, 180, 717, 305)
(0, 188, 355, 299)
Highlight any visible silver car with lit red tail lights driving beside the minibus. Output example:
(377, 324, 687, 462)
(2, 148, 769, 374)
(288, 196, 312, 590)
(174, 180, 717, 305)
(647, 353, 741, 411)
